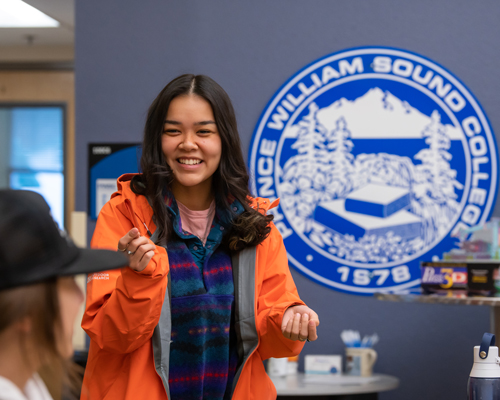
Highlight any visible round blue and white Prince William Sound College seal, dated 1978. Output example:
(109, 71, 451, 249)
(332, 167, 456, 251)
(249, 47, 497, 295)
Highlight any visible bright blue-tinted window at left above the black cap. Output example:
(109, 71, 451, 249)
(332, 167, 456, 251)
(0, 105, 64, 228)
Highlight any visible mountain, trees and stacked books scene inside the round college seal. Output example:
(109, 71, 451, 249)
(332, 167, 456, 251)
(278, 88, 463, 263)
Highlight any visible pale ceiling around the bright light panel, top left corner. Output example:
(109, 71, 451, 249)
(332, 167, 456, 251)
(0, 0, 75, 47)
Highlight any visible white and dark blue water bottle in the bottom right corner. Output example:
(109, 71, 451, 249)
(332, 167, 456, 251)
(467, 333, 500, 400)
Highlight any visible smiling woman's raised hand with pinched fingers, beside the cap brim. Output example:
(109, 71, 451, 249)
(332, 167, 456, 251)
(118, 228, 156, 272)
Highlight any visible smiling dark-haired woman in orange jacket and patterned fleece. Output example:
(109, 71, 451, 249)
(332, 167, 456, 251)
(82, 75, 319, 400)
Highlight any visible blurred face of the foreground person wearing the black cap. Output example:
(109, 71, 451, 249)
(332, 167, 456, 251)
(57, 276, 84, 358)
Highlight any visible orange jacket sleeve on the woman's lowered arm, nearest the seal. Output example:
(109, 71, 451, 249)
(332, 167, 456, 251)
(257, 223, 304, 360)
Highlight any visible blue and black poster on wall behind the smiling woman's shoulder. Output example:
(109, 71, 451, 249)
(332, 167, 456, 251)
(88, 143, 141, 219)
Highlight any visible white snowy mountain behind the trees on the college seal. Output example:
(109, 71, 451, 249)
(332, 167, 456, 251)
(285, 87, 463, 140)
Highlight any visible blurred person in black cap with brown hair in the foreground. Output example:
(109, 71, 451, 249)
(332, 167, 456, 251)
(0, 190, 127, 400)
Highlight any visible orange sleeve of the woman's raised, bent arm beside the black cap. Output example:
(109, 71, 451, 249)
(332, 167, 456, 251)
(82, 199, 169, 353)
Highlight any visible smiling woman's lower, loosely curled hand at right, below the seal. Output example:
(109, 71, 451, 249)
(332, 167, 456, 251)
(281, 306, 319, 342)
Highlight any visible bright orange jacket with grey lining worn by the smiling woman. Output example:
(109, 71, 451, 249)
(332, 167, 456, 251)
(81, 174, 304, 400)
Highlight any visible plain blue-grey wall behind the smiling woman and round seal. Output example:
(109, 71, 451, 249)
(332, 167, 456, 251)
(76, 0, 500, 400)
